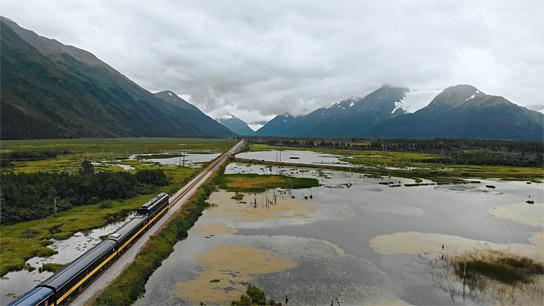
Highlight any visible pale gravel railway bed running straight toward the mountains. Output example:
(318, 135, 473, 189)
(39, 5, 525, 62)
(70, 141, 243, 305)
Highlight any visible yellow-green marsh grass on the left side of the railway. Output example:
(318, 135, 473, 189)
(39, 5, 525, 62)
(0, 138, 230, 276)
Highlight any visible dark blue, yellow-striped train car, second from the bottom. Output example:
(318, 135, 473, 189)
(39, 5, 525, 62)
(39, 240, 117, 305)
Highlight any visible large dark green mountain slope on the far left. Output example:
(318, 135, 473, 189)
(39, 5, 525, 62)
(0, 17, 233, 139)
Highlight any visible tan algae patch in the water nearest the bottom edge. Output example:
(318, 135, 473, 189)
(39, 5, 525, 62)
(172, 245, 296, 304)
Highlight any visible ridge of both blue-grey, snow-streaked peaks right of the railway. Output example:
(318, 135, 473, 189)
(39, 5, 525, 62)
(256, 84, 544, 140)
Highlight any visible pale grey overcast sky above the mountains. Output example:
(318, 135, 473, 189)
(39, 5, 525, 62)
(0, 0, 544, 121)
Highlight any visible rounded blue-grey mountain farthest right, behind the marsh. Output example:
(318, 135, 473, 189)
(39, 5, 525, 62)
(369, 85, 544, 140)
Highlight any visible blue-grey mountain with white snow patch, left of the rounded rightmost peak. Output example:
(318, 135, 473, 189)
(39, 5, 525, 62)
(256, 85, 409, 137)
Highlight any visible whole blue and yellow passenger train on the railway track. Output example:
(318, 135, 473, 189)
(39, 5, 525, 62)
(8, 193, 169, 306)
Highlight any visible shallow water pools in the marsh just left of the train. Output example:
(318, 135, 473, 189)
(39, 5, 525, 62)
(0, 215, 134, 305)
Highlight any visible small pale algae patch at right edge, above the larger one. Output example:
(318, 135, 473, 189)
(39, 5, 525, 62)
(490, 203, 544, 227)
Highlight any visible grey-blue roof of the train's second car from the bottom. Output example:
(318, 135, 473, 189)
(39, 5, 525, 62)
(40, 240, 116, 289)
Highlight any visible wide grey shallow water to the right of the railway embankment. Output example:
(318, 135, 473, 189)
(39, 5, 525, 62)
(137, 163, 544, 305)
